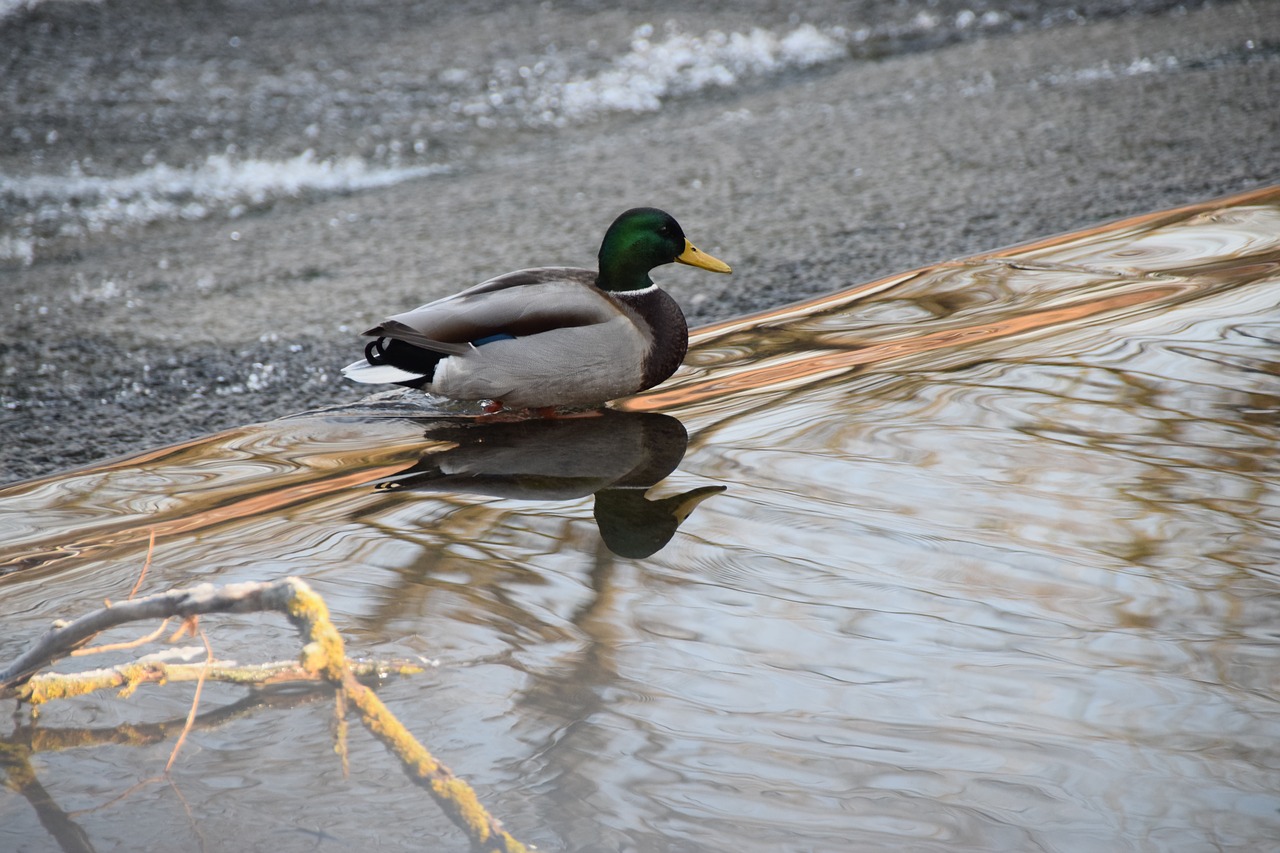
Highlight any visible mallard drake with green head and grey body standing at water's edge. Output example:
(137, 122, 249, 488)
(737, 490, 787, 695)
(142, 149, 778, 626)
(342, 207, 731, 411)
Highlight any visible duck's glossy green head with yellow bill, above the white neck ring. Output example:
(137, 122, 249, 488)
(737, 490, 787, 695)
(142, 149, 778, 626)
(598, 207, 732, 291)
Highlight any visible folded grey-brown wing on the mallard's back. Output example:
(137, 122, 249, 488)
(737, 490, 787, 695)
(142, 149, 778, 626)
(365, 266, 621, 355)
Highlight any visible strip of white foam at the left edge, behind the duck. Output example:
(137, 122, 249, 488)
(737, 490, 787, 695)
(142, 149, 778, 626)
(0, 151, 447, 264)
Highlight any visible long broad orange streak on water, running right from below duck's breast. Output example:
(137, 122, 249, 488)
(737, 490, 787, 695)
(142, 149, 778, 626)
(617, 280, 1187, 411)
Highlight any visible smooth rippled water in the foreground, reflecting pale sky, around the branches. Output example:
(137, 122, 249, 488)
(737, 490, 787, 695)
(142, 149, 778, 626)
(0, 188, 1280, 852)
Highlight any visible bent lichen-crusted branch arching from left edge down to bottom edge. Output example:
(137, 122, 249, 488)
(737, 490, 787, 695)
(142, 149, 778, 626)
(0, 578, 527, 853)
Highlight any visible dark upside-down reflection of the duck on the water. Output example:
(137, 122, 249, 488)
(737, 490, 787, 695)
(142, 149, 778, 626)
(375, 409, 724, 558)
